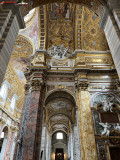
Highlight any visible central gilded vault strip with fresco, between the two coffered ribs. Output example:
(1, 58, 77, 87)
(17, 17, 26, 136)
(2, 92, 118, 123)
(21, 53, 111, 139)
(47, 3, 74, 51)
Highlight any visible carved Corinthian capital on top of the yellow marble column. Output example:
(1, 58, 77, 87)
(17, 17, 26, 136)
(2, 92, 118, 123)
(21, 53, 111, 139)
(75, 80, 89, 91)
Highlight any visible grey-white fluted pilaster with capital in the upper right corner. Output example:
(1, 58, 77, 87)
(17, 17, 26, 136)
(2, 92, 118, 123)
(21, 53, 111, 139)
(100, 0, 120, 77)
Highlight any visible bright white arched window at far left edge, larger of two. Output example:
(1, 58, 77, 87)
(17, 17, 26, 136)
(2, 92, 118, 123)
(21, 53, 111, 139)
(0, 80, 10, 105)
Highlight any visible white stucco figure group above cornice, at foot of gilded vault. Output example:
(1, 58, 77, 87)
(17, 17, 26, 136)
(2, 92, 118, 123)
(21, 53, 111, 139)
(48, 45, 71, 60)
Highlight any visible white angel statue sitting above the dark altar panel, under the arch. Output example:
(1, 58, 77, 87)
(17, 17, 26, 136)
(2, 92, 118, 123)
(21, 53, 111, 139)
(101, 97, 114, 112)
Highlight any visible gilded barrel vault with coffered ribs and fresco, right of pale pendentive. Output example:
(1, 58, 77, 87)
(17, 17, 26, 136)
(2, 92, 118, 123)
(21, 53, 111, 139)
(39, 3, 108, 52)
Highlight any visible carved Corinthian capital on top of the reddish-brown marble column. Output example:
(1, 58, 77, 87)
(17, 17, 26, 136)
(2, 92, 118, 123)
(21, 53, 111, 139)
(30, 78, 44, 91)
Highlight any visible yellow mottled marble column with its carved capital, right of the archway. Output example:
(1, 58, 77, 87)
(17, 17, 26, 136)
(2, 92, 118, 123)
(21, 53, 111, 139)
(76, 81, 97, 160)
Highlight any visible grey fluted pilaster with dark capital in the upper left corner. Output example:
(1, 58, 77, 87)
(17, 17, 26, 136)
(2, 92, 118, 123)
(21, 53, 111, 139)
(0, 4, 25, 86)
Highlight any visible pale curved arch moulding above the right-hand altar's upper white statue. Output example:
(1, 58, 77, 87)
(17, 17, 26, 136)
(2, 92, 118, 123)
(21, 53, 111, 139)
(90, 92, 120, 107)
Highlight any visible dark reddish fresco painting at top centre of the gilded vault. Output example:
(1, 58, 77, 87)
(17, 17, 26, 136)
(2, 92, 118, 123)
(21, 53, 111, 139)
(55, 3, 68, 17)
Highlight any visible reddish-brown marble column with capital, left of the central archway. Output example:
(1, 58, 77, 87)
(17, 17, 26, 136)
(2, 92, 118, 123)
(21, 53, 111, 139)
(22, 79, 44, 160)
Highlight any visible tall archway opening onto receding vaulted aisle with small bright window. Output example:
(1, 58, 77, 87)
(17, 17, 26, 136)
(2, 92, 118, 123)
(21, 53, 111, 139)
(41, 91, 80, 160)
